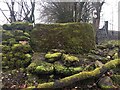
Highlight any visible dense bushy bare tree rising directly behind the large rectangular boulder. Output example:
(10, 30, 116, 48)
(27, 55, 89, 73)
(40, 2, 90, 22)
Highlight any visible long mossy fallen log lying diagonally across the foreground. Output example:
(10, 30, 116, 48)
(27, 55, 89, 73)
(29, 59, 120, 88)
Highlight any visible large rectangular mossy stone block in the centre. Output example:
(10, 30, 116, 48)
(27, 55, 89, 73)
(31, 23, 95, 53)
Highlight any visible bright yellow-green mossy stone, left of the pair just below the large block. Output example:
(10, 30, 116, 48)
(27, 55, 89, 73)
(45, 52, 62, 62)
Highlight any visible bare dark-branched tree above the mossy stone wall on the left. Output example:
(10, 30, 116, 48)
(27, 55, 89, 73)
(0, 0, 35, 23)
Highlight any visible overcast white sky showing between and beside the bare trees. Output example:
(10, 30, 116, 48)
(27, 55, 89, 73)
(0, 0, 120, 30)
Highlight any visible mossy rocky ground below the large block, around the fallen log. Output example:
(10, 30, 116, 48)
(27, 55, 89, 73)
(2, 38, 120, 89)
